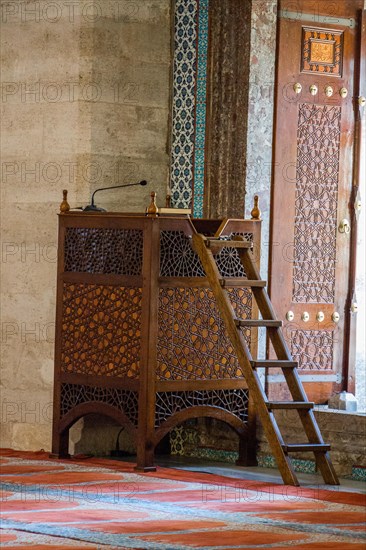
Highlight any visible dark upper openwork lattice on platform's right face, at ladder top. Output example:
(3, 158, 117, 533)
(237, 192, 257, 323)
(160, 231, 253, 277)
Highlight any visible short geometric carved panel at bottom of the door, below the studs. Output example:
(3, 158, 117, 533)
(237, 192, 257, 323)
(291, 330, 333, 370)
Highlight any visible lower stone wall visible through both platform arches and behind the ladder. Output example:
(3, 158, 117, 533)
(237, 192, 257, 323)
(70, 407, 366, 479)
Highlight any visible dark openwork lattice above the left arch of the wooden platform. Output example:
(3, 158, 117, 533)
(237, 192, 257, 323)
(61, 384, 138, 426)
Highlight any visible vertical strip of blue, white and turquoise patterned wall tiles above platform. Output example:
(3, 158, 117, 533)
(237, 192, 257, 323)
(170, 0, 209, 213)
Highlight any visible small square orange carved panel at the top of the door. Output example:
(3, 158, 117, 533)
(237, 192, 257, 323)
(301, 27, 343, 76)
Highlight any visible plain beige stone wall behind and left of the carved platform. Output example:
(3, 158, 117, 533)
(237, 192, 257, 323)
(0, 0, 171, 450)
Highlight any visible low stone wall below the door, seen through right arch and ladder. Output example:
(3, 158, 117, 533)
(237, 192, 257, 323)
(170, 407, 366, 479)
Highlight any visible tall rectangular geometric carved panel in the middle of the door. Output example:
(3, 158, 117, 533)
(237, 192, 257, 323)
(293, 104, 341, 303)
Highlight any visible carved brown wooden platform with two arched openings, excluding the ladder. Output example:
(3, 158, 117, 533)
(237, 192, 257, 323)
(52, 209, 261, 470)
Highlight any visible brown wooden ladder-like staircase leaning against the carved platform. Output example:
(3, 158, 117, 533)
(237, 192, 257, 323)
(193, 234, 339, 485)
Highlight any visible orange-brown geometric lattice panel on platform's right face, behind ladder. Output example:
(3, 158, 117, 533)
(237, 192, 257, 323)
(157, 288, 252, 380)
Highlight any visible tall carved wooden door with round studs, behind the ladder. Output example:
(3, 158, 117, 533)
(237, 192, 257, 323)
(268, 0, 363, 403)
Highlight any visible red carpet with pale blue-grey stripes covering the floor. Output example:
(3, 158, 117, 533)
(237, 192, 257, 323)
(0, 449, 366, 550)
